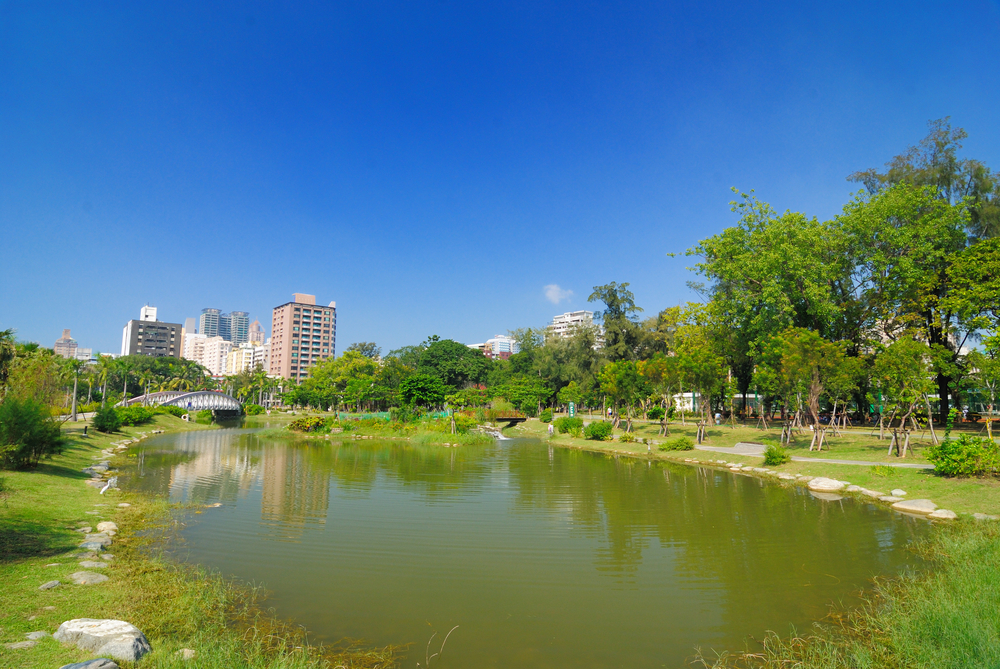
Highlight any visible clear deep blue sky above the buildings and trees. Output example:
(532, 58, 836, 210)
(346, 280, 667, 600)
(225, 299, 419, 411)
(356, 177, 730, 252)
(0, 0, 1000, 352)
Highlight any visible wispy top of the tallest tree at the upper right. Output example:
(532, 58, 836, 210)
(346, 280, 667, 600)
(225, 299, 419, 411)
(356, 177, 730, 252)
(847, 117, 1000, 239)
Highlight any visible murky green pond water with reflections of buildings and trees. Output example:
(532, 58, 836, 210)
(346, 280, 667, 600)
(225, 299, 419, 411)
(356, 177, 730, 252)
(127, 429, 929, 669)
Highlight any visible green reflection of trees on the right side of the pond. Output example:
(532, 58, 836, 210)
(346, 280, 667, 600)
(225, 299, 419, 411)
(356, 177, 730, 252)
(509, 442, 926, 629)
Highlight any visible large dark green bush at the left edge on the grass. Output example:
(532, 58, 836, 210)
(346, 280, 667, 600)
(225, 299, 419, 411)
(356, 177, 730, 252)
(0, 397, 66, 468)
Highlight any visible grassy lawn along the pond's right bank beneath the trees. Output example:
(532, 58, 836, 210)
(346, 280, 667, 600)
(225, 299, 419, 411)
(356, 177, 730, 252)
(504, 417, 1000, 514)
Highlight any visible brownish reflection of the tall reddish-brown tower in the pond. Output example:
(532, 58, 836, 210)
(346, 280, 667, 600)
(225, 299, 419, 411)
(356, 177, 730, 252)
(260, 447, 330, 528)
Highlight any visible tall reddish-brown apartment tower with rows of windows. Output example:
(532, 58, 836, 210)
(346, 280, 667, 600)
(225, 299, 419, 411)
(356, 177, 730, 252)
(270, 293, 337, 381)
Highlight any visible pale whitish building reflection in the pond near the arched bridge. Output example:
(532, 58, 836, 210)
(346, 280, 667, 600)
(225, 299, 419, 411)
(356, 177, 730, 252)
(170, 432, 259, 502)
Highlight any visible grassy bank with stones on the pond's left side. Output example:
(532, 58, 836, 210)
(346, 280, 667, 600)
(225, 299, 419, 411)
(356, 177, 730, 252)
(0, 416, 393, 669)
